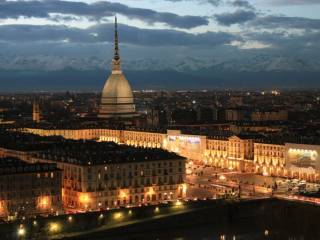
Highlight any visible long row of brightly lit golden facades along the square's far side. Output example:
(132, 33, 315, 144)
(23, 126, 320, 181)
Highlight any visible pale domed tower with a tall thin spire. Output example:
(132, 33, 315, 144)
(98, 17, 137, 118)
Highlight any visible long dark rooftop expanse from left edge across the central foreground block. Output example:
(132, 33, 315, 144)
(0, 130, 183, 165)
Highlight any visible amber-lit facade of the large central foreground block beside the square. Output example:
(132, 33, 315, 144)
(29, 155, 186, 211)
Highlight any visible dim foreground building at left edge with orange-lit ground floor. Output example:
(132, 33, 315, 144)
(0, 157, 62, 219)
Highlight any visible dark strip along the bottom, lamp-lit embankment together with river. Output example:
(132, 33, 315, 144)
(0, 199, 320, 240)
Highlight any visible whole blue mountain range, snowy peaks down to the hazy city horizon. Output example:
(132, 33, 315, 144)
(0, 54, 320, 91)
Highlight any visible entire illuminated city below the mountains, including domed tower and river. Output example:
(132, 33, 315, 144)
(0, 1, 320, 240)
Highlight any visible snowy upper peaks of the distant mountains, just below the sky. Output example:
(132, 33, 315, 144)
(0, 55, 320, 73)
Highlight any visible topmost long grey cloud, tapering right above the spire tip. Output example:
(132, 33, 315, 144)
(0, 0, 208, 29)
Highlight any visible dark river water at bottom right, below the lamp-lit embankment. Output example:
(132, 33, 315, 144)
(61, 199, 320, 240)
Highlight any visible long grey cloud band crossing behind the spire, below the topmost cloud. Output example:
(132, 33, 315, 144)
(0, 24, 239, 46)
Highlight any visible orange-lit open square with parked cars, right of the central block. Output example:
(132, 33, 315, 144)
(186, 161, 320, 203)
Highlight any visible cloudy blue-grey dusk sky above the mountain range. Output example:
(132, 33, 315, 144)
(0, 0, 320, 72)
